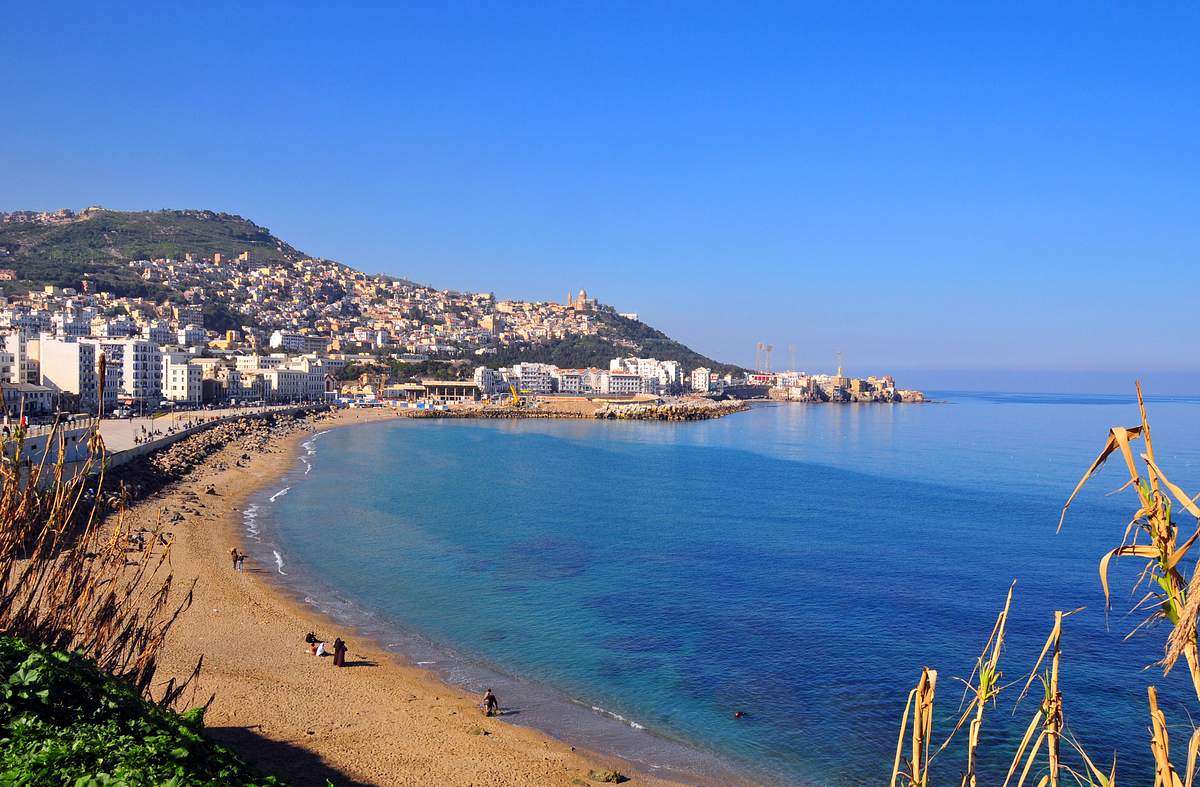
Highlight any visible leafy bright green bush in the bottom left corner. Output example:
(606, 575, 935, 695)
(0, 637, 283, 787)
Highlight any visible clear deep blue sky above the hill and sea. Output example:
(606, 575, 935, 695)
(0, 2, 1200, 392)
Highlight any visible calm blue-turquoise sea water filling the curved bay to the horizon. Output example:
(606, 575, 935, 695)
(247, 394, 1200, 785)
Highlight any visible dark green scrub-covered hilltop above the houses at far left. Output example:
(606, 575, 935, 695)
(0, 209, 305, 299)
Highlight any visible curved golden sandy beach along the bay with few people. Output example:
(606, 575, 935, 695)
(128, 410, 696, 786)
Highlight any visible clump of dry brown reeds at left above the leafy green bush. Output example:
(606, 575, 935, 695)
(0, 415, 191, 703)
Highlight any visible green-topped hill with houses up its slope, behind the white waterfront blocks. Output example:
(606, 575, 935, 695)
(0, 208, 739, 373)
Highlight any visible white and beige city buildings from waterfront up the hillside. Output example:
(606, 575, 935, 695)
(0, 233, 905, 413)
